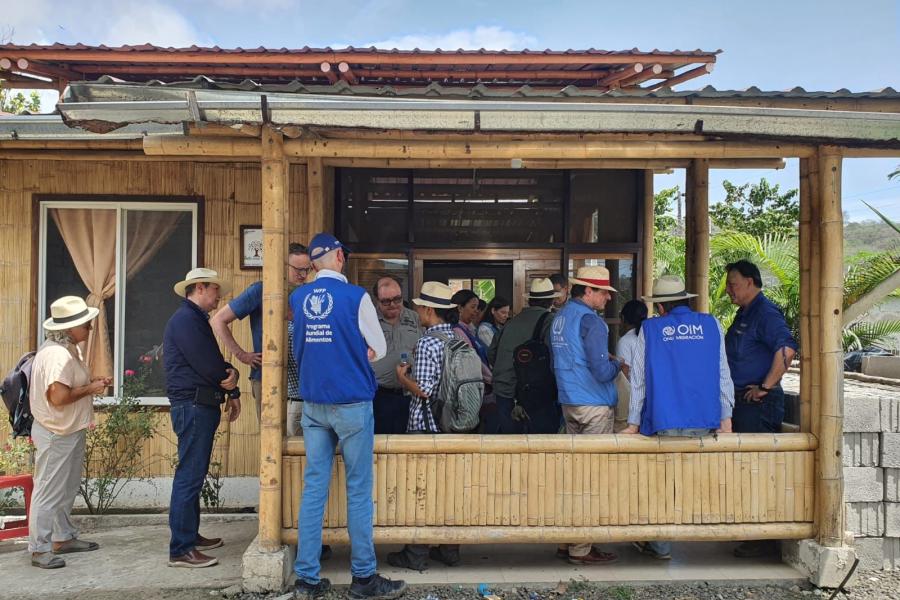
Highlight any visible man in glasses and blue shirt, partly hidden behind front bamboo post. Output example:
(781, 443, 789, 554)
(210, 243, 311, 422)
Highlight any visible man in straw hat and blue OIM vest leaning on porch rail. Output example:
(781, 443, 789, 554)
(621, 275, 734, 560)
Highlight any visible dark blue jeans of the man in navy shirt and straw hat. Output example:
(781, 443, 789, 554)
(169, 401, 222, 558)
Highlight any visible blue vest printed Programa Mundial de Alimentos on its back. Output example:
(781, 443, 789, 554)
(290, 277, 377, 404)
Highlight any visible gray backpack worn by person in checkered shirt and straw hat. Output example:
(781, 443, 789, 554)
(428, 332, 484, 433)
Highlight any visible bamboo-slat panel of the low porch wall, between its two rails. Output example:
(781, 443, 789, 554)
(283, 436, 814, 531)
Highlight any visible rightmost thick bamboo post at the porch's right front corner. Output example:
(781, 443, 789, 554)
(815, 146, 844, 546)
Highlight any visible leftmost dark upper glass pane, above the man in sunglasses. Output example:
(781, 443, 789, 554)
(340, 169, 409, 249)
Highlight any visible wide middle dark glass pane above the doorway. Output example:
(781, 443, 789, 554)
(413, 169, 565, 244)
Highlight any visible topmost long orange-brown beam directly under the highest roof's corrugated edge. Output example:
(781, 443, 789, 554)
(5, 48, 716, 65)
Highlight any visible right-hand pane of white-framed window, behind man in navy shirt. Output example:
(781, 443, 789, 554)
(122, 210, 193, 397)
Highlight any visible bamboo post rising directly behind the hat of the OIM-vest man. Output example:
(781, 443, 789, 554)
(685, 159, 709, 312)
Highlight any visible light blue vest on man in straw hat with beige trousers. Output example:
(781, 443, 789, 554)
(550, 301, 619, 406)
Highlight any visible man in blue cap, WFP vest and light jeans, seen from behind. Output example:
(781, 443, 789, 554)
(290, 233, 406, 599)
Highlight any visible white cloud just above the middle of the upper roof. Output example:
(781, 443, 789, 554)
(365, 25, 537, 50)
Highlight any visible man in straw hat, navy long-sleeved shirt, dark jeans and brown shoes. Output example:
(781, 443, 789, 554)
(163, 268, 241, 568)
